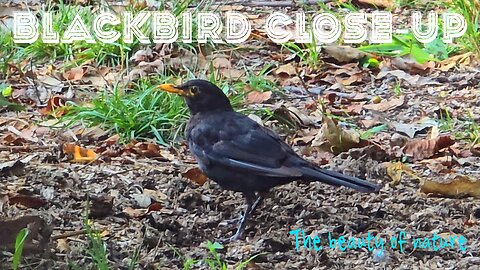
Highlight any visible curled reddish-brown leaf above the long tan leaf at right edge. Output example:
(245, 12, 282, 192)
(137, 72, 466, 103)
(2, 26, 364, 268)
(402, 135, 455, 160)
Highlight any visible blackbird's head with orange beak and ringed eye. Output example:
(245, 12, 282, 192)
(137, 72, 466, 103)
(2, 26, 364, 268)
(158, 80, 233, 114)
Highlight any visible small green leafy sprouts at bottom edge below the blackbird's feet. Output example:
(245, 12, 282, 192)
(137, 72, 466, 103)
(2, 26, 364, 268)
(183, 241, 259, 270)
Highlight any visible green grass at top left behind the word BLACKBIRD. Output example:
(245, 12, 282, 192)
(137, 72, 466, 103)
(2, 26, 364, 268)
(0, 0, 215, 73)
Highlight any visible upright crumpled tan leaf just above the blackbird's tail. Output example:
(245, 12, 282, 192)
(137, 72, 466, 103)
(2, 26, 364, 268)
(312, 116, 361, 153)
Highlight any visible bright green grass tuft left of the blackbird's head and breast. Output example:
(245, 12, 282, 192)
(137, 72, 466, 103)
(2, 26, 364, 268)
(62, 77, 188, 145)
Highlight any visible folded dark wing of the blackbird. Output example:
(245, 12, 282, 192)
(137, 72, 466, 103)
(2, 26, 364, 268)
(189, 113, 302, 178)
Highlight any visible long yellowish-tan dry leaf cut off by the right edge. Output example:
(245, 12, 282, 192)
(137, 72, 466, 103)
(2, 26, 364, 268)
(420, 175, 480, 198)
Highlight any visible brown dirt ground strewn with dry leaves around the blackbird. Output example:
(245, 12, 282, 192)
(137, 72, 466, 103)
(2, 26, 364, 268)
(0, 1, 480, 270)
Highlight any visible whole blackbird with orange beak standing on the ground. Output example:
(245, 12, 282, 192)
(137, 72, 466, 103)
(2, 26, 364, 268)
(158, 80, 381, 240)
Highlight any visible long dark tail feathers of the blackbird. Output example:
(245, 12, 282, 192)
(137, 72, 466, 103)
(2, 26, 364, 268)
(302, 167, 382, 192)
